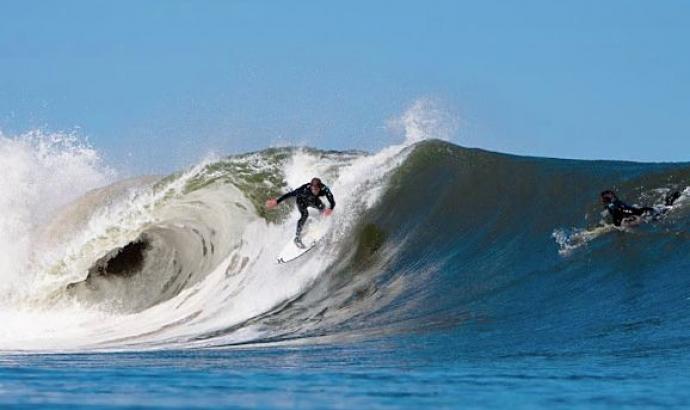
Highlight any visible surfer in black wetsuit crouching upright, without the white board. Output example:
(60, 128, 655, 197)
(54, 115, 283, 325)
(266, 178, 335, 249)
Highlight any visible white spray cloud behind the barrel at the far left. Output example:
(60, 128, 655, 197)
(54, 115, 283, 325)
(0, 131, 115, 303)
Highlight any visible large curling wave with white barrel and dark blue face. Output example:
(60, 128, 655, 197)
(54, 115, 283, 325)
(0, 136, 690, 351)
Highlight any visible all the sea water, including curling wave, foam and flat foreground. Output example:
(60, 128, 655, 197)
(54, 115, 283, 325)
(0, 135, 690, 409)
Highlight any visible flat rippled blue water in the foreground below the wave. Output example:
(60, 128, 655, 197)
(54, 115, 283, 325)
(0, 338, 690, 409)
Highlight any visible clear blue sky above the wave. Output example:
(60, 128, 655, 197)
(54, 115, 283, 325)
(0, 0, 690, 171)
